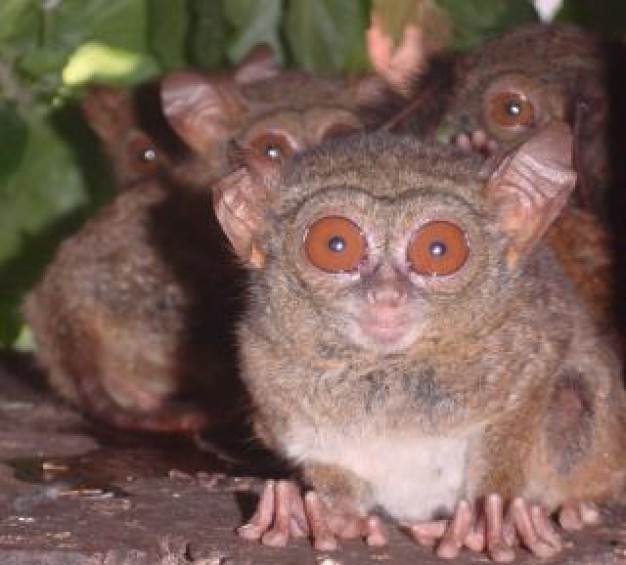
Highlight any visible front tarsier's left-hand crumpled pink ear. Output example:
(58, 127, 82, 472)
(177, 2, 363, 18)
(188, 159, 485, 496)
(212, 149, 281, 269)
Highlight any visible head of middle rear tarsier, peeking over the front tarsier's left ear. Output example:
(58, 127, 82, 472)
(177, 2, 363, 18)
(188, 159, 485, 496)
(161, 46, 377, 185)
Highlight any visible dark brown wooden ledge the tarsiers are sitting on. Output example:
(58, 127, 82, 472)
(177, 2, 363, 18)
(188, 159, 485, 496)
(0, 352, 626, 565)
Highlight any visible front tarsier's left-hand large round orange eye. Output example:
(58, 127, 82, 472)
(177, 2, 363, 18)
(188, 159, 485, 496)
(304, 216, 367, 273)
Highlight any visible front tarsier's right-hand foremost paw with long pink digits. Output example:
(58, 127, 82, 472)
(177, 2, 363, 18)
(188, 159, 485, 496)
(408, 494, 563, 562)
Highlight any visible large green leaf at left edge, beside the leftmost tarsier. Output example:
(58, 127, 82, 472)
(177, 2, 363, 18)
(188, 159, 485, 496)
(0, 106, 113, 345)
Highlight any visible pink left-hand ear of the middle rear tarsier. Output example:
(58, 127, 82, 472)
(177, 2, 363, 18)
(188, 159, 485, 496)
(161, 71, 244, 159)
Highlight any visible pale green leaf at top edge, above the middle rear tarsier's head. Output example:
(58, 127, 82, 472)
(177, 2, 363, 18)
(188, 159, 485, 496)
(223, 0, 284, 63)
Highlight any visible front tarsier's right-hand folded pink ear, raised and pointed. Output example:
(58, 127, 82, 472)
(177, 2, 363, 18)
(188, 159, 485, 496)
(484, 121, 576, 266)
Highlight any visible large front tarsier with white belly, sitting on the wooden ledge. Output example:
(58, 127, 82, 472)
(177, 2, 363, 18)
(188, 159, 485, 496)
(215, 122, 626, 561)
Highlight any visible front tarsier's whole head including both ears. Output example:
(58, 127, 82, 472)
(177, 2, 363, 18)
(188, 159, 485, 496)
(216, 122, 576, 353)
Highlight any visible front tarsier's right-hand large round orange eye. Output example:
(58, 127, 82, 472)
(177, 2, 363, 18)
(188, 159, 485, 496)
(407, 221, 470, 277)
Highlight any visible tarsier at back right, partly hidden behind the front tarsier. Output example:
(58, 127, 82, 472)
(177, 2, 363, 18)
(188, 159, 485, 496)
(370, 24, 614, 326)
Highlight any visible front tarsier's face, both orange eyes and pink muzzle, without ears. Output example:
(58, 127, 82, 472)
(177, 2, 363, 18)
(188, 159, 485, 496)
(288, 187, 486, 353)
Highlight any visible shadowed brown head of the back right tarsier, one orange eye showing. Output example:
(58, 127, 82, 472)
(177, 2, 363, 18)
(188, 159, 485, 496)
(438, 24, 609, 208)
